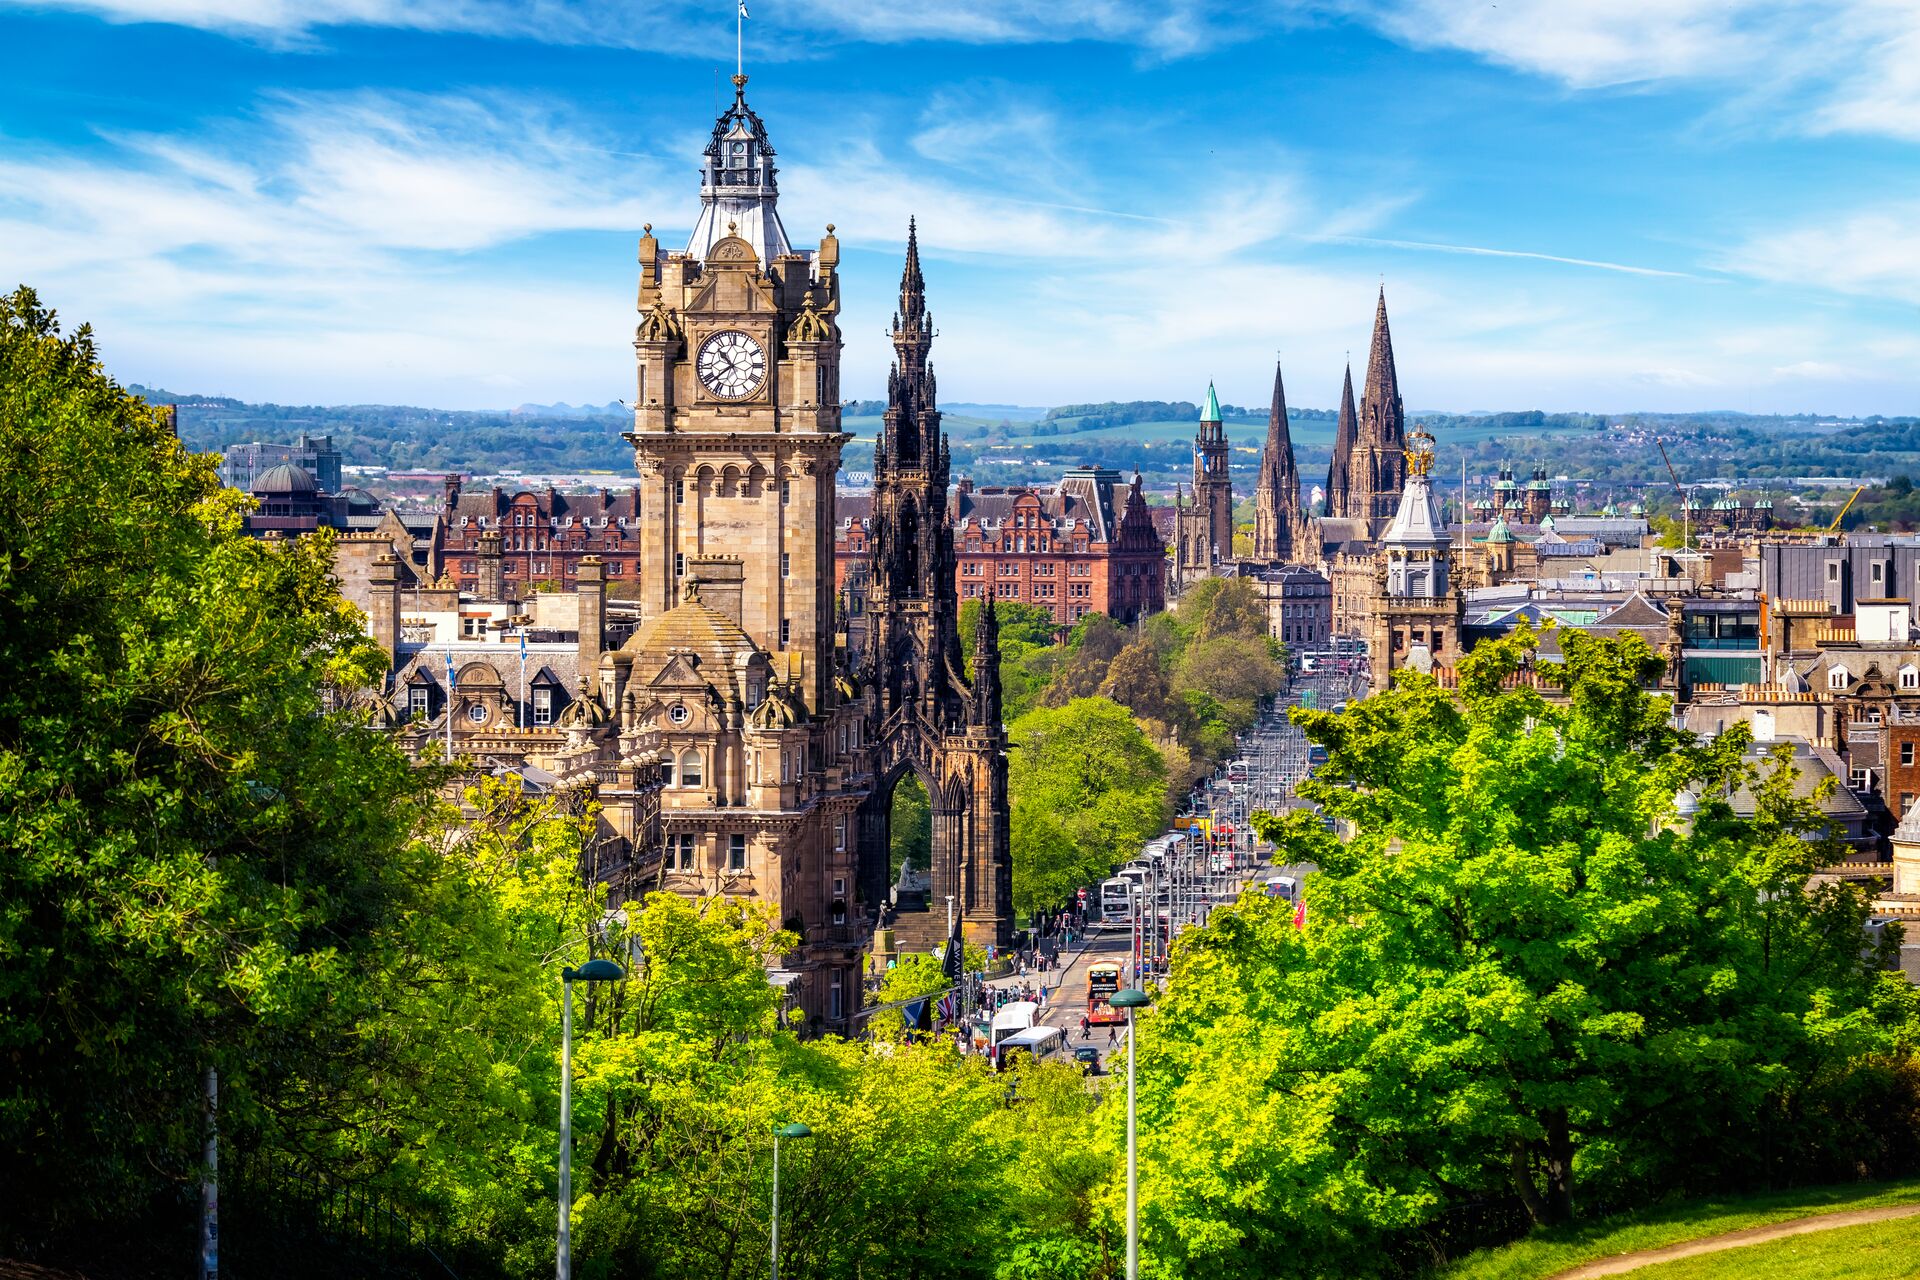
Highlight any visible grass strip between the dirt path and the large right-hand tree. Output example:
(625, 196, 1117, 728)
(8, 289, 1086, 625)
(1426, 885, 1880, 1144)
(1436, 1178, 1920, 1280)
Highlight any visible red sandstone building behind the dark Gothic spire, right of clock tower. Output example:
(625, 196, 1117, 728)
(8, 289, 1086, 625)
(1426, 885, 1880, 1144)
(833, 466, 1167, 643)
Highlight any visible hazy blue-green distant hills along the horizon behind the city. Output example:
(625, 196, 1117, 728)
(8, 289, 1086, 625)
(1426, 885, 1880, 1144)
(131, 386, 1920, 493)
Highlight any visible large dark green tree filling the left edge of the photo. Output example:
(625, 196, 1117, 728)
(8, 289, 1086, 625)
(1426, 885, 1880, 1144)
(0, 288, 434, 1234)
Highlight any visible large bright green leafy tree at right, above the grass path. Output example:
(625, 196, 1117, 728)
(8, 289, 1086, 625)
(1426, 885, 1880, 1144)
(1142, 633, 1914, 1276)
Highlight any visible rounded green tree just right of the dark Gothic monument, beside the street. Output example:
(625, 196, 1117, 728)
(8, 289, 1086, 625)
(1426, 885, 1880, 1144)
(1008, 699, 1167, 912)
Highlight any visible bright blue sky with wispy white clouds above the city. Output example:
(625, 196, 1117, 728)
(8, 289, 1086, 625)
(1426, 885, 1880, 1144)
(0, 0, 1920, 415)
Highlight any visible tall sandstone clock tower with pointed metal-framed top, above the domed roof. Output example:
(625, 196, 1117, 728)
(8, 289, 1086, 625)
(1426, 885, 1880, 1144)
(626, 75, 847, 712)
